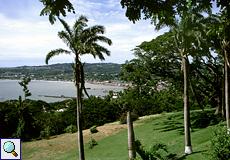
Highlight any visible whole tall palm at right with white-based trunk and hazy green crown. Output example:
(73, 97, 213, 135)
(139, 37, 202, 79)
(156, 4, 208, 154)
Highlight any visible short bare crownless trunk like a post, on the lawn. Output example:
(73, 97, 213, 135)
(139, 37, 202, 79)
(127, 111, 136, 159)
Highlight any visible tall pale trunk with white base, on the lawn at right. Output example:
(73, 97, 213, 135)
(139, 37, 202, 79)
(182, 55, 192, 154)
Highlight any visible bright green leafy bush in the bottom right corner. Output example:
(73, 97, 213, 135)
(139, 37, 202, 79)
(204, 125, 230, 160)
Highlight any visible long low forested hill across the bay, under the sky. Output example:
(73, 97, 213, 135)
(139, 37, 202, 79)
(0, 63, 121, 81)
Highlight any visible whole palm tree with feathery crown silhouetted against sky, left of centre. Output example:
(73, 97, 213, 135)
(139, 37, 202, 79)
(45, 16, 112, 160)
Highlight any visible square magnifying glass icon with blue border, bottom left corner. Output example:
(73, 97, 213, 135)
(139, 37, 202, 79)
(0, 138, 21, 160)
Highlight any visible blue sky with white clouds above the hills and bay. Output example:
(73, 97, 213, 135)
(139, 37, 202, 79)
(0, 0, 168, 67)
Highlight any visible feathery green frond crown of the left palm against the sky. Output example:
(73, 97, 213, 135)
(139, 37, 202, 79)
(46, 16, 112, 64)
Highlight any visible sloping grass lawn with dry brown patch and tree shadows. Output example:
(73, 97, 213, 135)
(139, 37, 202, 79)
(22, 110, 221, 160)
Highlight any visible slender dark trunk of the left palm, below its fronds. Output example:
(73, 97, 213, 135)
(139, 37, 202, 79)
(75, 58, 85, 160)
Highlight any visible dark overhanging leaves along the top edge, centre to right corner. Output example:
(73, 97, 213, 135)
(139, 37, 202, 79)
(121, 0, 230, 26)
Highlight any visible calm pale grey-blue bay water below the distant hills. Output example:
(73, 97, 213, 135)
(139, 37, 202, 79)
(0, 80, 124, 102)
